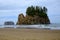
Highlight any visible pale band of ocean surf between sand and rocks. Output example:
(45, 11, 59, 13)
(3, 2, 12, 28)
(0, 24, 60, 30)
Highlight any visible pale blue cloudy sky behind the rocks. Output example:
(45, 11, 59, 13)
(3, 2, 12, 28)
(0, 0, 60, 24)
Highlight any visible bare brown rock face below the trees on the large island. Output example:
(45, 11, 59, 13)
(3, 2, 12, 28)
(17, 14, 50, 25)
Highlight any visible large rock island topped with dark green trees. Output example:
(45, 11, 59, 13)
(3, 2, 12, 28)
(17, 6, 50, 25)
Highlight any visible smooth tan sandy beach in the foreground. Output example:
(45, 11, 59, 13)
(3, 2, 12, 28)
(0, 28, 60, 40)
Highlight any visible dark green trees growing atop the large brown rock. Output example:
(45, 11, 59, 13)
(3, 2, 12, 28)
(26, 6, 47, 17)
